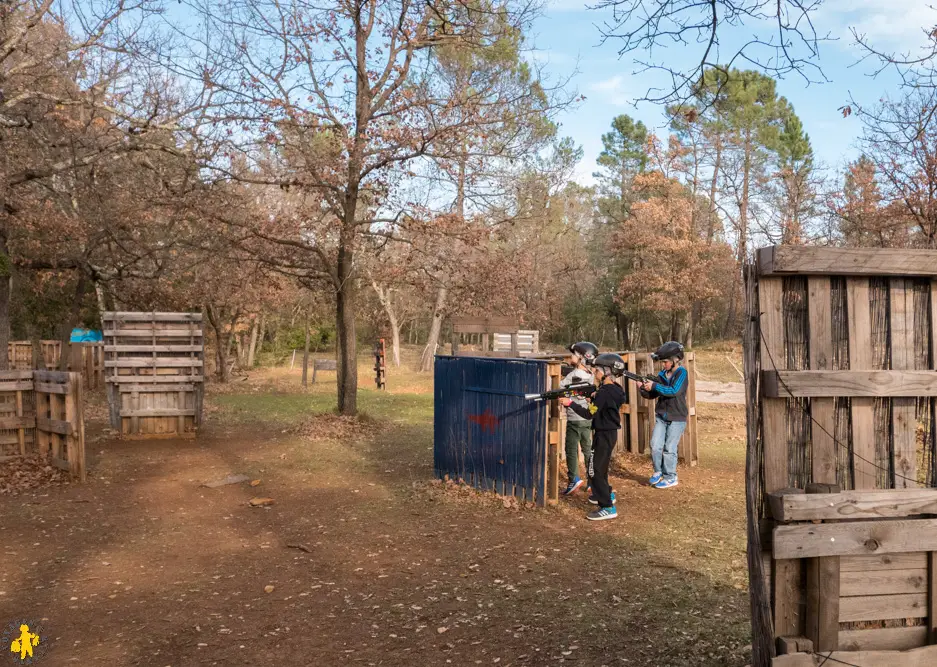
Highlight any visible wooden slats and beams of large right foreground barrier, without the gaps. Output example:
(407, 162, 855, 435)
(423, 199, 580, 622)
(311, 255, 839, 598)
(758, 248, 937, 664)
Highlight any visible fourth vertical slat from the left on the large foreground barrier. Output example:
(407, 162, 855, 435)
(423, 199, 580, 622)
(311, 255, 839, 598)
(889, 279, 916, 489)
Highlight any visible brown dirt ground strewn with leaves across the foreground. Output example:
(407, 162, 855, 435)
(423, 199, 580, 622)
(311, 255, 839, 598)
(0, 394, 748, 667)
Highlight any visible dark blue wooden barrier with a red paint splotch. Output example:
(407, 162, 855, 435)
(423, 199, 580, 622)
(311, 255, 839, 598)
(433, 356, 547, 505)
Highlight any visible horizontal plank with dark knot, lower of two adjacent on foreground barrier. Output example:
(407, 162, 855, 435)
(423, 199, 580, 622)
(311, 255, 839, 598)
(772, 519, 937, 560)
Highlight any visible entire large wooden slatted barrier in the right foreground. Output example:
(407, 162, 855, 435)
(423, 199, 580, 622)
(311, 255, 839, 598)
(745, 247, 937, 667)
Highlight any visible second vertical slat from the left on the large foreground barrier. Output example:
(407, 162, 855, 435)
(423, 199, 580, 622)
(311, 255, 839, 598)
(807, 277, 837, 486)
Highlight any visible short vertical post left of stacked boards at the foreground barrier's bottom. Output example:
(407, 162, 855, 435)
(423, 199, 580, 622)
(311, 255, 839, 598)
(806, 486, 840, 651)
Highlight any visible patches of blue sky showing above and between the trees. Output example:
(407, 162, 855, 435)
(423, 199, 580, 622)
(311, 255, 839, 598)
(532, 0, 937, 183)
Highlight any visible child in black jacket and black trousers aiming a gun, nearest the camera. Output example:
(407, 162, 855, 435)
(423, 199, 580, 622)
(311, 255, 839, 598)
(561, 353, 625, 521)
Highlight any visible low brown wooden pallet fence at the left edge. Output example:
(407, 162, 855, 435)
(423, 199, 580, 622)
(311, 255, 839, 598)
(0, 371, 85, 481)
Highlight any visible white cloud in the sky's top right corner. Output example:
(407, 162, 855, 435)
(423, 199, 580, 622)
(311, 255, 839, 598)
(815, 0, 937, 51)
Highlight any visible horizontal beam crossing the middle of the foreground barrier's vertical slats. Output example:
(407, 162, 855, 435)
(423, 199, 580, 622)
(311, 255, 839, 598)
(762, 370, 937, 400)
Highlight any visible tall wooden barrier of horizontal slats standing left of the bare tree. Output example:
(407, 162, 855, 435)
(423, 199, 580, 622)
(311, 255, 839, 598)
(103, 313, 205, 439)
